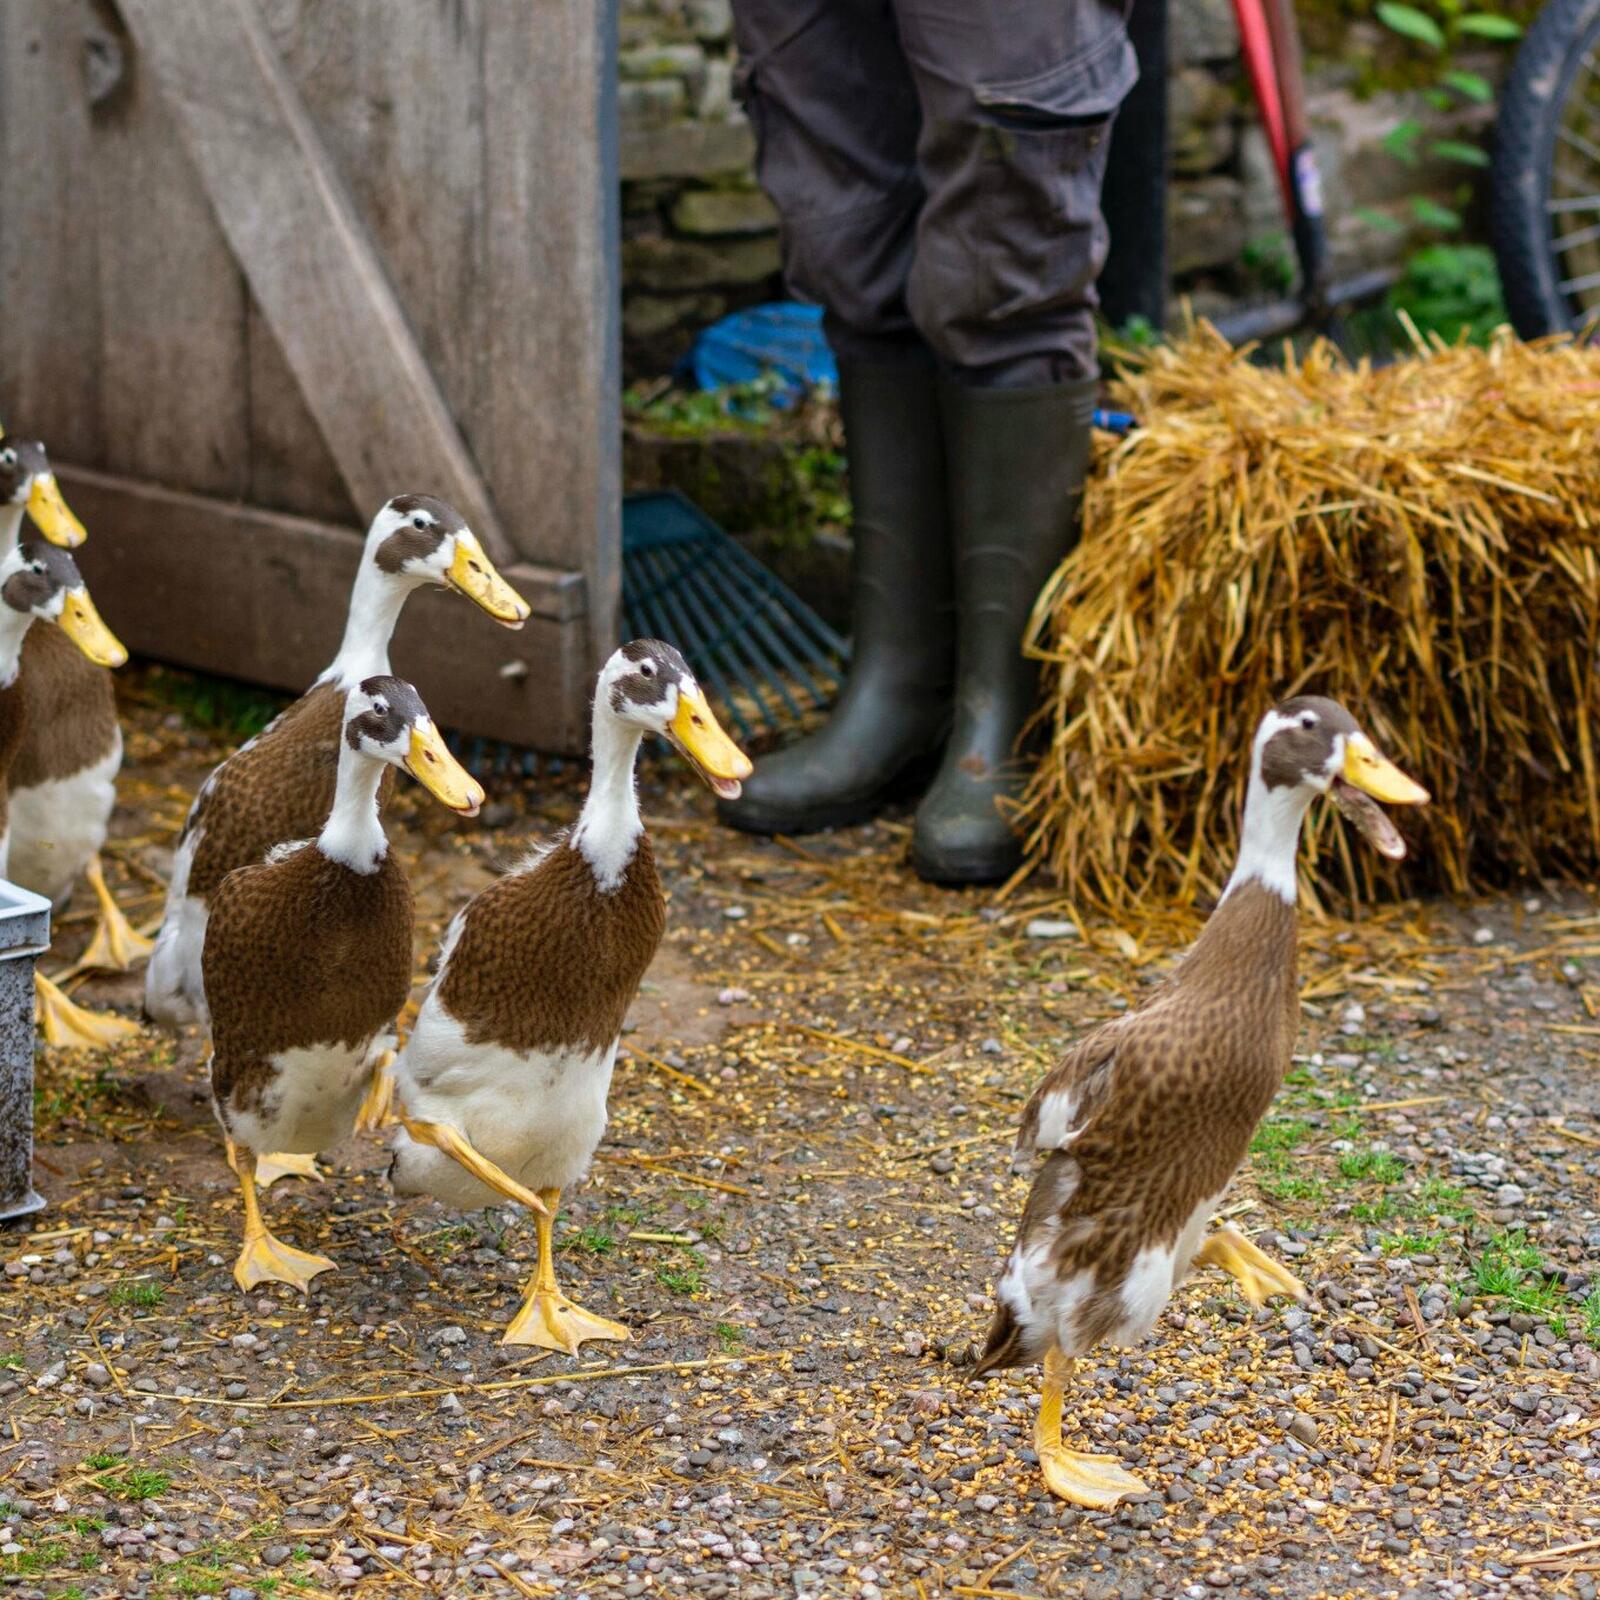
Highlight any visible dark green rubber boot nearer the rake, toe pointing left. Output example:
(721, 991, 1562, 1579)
(717, 345, 955, 834)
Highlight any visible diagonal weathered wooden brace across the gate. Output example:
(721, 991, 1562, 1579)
(120, 0, 507, 560)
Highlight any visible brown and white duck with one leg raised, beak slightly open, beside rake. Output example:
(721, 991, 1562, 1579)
(389, 638, 750, 1354)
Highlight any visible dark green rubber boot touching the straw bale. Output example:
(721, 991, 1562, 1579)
(912, 379, 1096, 883)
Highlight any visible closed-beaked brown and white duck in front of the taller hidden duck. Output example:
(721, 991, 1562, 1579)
(202, 675, 505, 1290)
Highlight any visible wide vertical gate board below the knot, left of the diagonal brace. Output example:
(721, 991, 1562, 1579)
(86, 0, 250, 499)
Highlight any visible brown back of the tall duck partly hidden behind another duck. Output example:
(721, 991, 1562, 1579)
(182, 683, 394, 902)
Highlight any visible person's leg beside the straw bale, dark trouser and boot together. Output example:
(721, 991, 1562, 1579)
(896, 0, 1136, 882)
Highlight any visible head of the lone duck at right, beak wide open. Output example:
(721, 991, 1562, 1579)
(1251, 694, 1429, 861)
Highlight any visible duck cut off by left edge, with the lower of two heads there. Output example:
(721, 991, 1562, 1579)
(0, 541, 138, 1046)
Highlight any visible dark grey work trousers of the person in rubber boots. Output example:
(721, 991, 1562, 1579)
(733, 0, 1138, 387)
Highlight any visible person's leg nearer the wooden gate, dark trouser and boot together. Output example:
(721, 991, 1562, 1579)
(720, 0, 955, 834)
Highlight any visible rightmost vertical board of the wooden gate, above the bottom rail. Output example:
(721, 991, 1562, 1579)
(472, 0, 622, 661)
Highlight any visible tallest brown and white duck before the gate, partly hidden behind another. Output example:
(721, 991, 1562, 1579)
(144, 494, 530, 1027)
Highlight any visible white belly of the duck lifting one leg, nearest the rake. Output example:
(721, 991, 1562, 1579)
(390, 987, 616, 1210)
